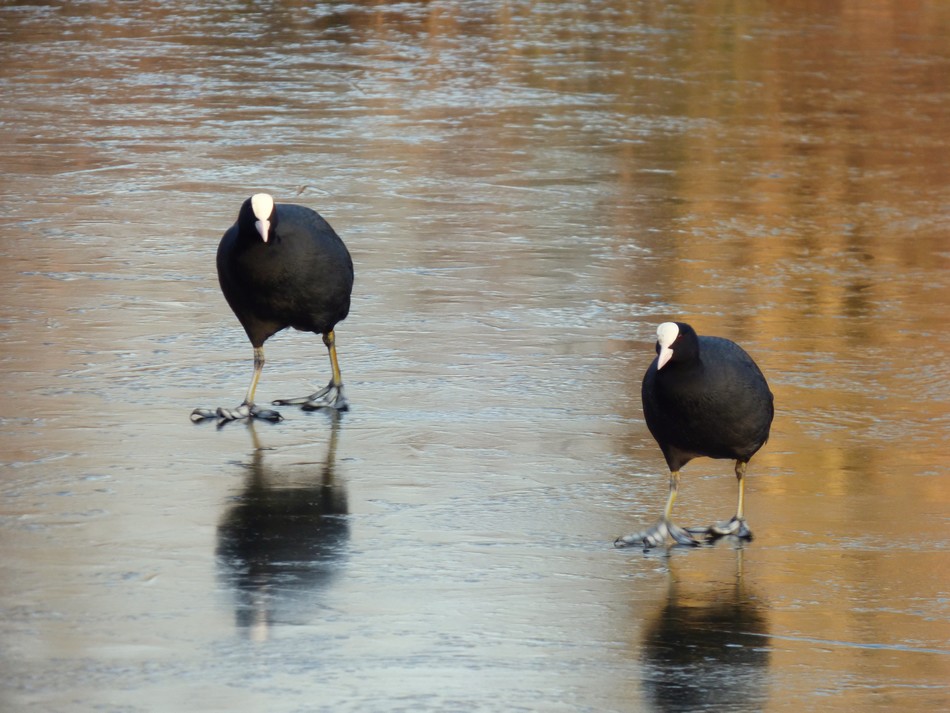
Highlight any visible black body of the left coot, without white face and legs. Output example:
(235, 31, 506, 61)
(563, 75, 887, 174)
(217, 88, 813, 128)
(218, 199, 353, 347)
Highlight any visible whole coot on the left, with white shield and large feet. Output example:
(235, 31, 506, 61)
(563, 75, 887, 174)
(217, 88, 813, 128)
(191, 193, 353, 421)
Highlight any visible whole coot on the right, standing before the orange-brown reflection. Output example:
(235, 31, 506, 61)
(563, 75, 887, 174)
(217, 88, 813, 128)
(615, 322, 774, 547)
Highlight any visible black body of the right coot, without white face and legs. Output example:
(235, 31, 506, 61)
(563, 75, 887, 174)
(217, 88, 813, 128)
(641, 324, 774, 470)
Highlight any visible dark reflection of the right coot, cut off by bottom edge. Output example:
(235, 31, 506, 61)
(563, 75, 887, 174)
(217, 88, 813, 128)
(638, 545, 770, 713)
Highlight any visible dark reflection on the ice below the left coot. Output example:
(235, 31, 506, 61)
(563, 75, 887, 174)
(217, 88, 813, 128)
(216, 414, 350, 641)
